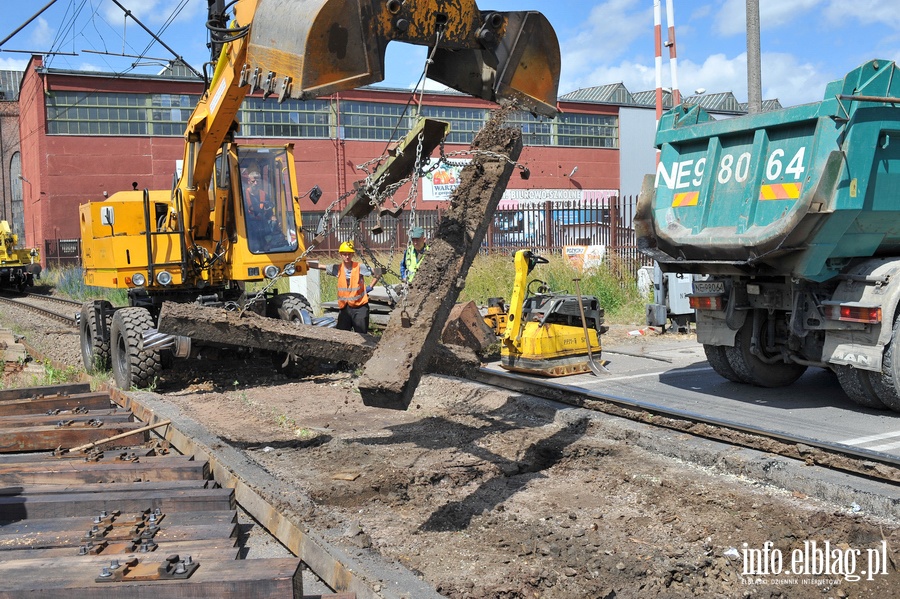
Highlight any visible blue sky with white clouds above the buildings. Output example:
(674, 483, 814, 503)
(0, 0, 900, 106)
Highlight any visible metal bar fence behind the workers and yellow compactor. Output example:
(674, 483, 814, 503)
(303, 196, 653, 277)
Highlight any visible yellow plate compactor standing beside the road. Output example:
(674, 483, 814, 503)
(500, 250, 608, 377)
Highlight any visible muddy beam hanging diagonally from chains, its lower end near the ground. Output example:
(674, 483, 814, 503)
(359, 108, 522, 410)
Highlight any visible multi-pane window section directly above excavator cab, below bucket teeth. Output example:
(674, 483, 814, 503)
(238, 98, 332, 139)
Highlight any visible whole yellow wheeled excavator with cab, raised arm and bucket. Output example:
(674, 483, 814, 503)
(79, 0, 560, 389)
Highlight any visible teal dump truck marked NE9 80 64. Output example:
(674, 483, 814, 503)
(635, 60, 900, 411)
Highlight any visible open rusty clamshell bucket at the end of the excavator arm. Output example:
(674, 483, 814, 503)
(242, 0, 560, 117)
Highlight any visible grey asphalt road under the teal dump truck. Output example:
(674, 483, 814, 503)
(492, 339, 900, 457)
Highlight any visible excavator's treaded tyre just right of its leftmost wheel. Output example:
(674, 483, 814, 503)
(110, 308, 162, 391)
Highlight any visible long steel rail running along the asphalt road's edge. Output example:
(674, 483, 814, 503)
(473, 368, 900, 479)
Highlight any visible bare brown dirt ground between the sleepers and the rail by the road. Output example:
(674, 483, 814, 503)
(0, 313, 900, 599)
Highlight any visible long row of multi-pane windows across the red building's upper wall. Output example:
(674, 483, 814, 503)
(47, 91, 619, 148)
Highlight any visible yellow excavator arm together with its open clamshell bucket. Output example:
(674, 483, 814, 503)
(176, 0, 560, 241)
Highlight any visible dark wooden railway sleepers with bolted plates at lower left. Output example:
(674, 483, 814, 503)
(0, 384, 358, 599)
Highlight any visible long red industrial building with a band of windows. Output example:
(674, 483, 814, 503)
(19, 56, 624, 264)
